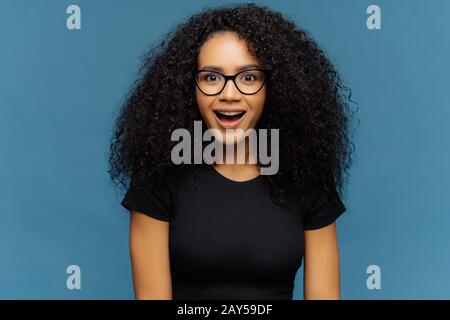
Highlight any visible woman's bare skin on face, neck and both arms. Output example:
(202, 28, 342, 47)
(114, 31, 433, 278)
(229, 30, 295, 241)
(129, 32, 340, 300)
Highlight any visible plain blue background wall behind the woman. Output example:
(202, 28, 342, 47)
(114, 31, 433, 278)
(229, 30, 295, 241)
(0, 0, 450, 299)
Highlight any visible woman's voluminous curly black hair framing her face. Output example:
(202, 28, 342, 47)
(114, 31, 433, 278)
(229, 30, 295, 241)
(108, 3, 354, 209)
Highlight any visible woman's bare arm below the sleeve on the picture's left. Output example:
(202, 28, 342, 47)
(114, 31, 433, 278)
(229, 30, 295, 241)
(129, 210, 172, 300)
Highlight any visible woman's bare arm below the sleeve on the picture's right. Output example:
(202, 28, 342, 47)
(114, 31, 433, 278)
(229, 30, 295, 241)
(303, 222, 340, 300)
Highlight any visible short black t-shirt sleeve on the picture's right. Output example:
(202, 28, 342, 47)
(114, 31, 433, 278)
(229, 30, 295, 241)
(303, 175, 346, 230)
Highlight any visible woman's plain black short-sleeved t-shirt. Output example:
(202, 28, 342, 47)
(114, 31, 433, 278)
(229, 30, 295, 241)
(121, 164, 346, 300)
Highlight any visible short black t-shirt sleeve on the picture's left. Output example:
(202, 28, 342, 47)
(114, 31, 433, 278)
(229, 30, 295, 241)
(121, 171, 178, 221)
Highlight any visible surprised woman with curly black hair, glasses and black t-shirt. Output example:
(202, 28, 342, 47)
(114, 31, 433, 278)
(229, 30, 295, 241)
(110, 4, 352, 299)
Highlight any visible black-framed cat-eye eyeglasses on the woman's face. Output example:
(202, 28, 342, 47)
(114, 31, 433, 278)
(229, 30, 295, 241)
(195, 68, 268, 96)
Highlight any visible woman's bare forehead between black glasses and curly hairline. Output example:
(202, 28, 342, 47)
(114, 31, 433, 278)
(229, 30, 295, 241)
(197, 31, 260, 72)
